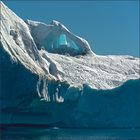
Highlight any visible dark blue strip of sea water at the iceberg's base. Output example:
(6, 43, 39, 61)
(0, 127, 140, 140)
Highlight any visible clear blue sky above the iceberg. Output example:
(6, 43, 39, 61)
(2, 0, 140, 57)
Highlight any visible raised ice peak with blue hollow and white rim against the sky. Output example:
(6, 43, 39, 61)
(26, 20, 94, 56)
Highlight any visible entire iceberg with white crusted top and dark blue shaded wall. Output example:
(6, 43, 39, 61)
(0, 2, 140, 127)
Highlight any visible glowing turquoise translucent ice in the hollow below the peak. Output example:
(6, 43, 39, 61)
(43, 33, 84, 56)
